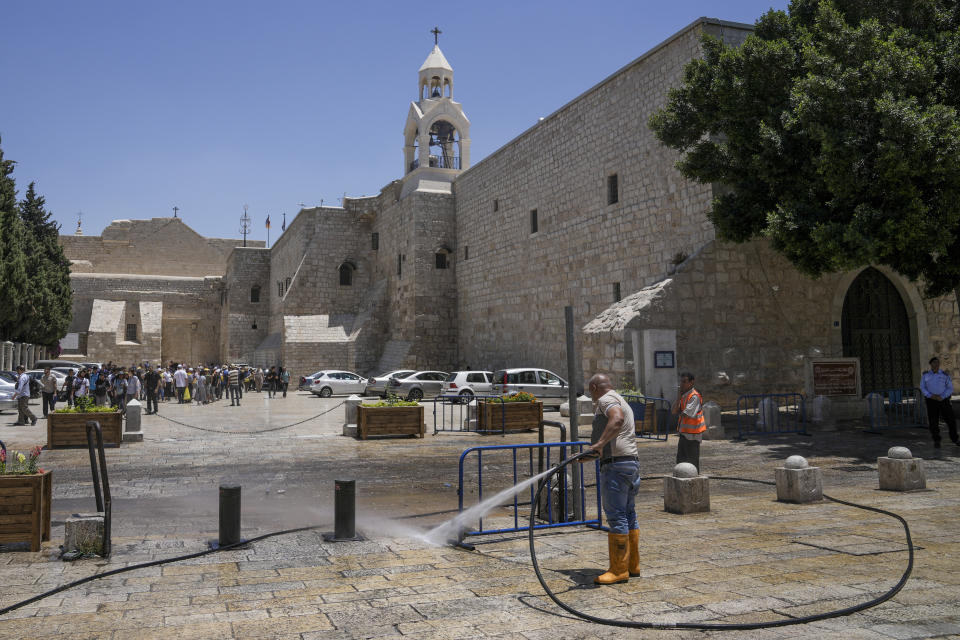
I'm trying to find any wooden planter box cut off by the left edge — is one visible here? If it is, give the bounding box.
[0,471,53,551]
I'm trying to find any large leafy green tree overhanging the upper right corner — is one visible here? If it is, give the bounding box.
[650,0,960,301]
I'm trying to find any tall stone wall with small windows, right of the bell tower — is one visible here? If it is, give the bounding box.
[455,23,748,373]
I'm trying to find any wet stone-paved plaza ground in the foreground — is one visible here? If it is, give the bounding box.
[0,394,960,640]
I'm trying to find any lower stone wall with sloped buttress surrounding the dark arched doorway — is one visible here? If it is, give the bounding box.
[583,241,960,408]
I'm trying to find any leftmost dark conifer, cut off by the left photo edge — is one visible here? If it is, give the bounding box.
[0,139,30,340]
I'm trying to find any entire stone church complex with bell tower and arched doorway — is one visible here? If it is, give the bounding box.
[62,18,960,404]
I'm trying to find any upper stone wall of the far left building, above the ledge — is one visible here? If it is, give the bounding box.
[60,218,264,277]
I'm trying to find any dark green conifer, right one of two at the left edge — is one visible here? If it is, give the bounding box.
[20,182,72,346]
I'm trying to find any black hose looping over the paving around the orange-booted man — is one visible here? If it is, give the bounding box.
[528,450,913,631]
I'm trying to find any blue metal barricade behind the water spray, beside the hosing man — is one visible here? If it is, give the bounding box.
[457,442,604,536]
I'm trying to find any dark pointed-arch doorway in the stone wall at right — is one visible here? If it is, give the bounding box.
[843,267,913,393]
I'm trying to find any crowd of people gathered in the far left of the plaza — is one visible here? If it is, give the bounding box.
[30,362,290,416]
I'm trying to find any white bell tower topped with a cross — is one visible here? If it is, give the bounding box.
[402,27,470,195]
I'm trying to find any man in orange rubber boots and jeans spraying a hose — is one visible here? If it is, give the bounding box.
[580,373,640,584]
